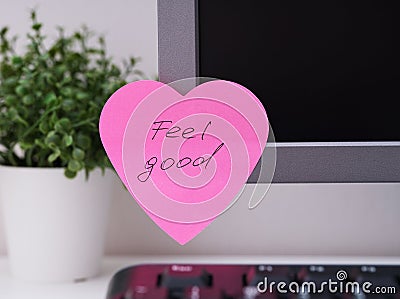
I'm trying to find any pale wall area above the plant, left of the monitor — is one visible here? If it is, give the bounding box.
[0,0,157,78]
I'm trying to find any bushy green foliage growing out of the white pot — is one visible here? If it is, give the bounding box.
[0,10,141,178]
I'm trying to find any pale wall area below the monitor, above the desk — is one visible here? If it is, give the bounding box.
[107,183,400,257]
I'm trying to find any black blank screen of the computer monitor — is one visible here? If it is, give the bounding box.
[198,0,400,142]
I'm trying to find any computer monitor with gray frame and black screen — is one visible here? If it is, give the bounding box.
[158,0,400,183]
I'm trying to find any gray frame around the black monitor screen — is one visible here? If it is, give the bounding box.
[158,0,400,183]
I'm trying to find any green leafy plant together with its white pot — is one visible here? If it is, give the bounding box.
[0,11,140,281]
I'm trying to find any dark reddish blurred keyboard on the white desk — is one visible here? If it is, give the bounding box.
[107,264,400,299]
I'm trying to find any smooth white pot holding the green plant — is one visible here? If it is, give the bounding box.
[0,166,114,282]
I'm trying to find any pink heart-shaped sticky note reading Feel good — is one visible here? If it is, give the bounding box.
[100,80,269,244]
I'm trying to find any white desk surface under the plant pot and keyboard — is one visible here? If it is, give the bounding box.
[0,256,400,299]
